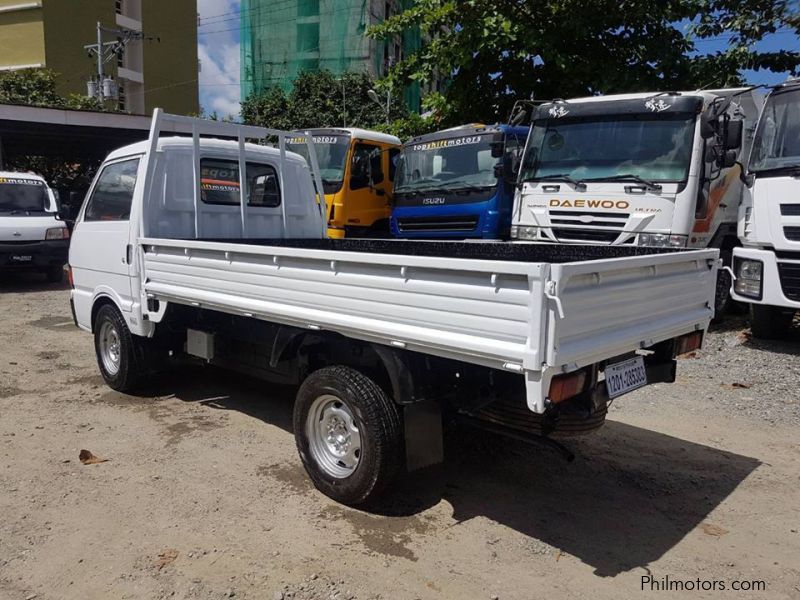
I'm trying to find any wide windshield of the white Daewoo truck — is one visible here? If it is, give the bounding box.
[520,113,695,182]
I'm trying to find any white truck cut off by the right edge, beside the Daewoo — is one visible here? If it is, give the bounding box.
[731,80,800,338]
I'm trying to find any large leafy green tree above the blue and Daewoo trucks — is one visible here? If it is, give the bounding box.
[367,0,800,122]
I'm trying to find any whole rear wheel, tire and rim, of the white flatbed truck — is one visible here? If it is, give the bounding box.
[294,366,403,506]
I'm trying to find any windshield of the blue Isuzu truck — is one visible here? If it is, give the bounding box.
[394,134,497,193]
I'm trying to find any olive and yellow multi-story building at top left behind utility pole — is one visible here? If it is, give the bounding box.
[0,0,199,114]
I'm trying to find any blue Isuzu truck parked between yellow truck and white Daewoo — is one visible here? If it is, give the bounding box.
[390,123,528,239]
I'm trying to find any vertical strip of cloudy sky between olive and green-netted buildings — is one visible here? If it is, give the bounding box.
[197,0,240,117]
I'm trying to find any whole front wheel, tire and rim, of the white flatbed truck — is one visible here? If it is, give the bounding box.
[94,304,148,392]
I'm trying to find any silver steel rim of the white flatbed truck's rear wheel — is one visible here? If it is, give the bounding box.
[306,394,361,479]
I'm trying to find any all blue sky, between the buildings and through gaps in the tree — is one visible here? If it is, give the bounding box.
[197,0,800,117]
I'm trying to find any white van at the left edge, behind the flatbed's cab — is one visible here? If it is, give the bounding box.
[0,171,69,282]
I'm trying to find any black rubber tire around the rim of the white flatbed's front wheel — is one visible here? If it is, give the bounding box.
[93,304,149,392]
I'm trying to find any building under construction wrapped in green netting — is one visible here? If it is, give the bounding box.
[241,0,420,110]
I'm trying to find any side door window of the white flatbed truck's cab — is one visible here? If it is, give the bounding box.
[83,158,139,221]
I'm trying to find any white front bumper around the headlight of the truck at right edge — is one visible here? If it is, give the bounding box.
[731,248,800,309]
